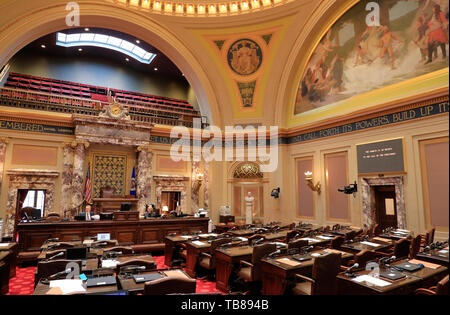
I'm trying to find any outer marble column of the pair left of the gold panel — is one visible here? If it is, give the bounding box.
[61,143,74,217]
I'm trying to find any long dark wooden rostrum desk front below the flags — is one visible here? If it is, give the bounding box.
[17,217,209,251]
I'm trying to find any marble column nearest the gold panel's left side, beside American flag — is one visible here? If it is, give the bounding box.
[72,142,89,208]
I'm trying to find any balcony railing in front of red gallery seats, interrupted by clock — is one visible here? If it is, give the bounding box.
[0,88,206,127]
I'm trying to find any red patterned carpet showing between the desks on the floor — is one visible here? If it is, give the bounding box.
[8,256,224,295]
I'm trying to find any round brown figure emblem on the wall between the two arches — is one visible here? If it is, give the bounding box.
[227,39,262,75]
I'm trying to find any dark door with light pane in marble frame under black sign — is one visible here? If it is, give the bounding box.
[373,185,398,229]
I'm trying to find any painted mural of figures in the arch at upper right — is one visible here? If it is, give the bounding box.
[294,0,449,114]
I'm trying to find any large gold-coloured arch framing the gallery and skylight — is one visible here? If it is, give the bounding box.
[0,1,223,126]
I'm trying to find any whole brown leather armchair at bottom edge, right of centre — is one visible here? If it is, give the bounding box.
[292,253,341,295]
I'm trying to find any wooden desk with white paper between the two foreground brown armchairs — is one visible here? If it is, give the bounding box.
[261,249,353,295]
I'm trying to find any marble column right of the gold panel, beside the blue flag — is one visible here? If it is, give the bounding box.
[136,146,153,214]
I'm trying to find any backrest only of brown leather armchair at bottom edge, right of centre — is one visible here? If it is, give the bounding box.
[311,253,341,295]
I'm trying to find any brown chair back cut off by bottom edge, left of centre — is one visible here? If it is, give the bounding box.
[144,277,197,295]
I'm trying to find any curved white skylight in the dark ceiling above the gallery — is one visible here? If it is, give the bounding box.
[56,32,156,64]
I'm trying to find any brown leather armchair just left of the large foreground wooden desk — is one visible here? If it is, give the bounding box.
[238,243,277,282]
